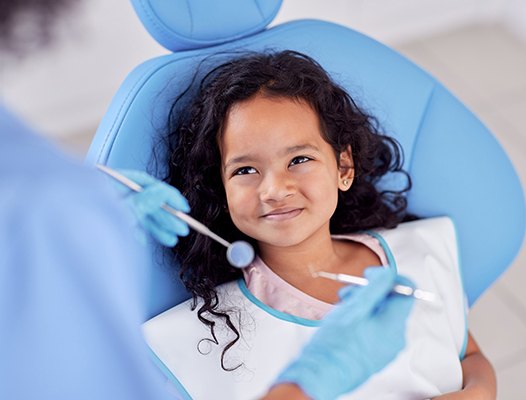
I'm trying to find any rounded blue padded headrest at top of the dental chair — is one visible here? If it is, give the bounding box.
[132,0,282,52]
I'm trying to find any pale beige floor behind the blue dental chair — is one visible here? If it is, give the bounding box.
[56,25,526,400]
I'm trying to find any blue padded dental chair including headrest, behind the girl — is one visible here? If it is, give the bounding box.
[87,0,525,317]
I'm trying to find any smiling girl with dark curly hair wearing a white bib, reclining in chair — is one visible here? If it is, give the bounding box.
[145,51,495,399]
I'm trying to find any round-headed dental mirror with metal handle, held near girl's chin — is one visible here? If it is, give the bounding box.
[97,164,255,268]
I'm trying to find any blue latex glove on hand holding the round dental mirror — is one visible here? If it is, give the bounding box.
[117,170,190,247]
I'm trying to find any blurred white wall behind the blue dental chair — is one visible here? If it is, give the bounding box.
[0,0,526,140]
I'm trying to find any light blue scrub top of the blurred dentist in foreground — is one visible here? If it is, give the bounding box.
[0,105,177,400]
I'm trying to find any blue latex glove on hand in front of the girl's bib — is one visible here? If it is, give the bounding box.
[276,267,414,400]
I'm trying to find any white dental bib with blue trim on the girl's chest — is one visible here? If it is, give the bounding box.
[143,217,467,400]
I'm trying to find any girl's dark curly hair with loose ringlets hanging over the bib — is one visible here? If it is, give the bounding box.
[167,51,411,369]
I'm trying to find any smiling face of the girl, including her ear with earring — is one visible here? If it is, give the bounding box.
[220,95,353,250]
